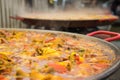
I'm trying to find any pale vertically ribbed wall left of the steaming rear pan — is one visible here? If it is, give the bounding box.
[0,0,25,28]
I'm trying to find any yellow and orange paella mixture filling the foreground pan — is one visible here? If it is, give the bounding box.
[0,30,115,80]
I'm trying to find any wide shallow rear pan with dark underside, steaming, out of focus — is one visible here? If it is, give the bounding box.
[10,14,118,28]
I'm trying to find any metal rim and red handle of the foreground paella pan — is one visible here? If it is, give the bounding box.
[1,29,120,80]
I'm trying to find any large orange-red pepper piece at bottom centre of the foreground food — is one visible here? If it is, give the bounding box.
[48,63,68,73]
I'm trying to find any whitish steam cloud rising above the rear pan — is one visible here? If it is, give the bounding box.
[7,0,109,16]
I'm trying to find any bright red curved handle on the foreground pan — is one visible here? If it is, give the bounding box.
[87,30,120,42]
